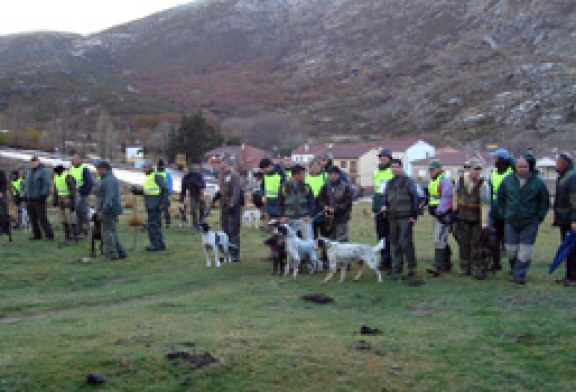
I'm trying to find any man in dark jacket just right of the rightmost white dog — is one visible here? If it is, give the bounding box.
[383,159,418,278]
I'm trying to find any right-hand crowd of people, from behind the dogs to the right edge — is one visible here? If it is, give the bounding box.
[260,148,576,284]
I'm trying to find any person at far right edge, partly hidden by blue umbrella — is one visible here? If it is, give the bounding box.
[554,153,576,284]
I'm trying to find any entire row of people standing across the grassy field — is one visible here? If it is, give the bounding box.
[0,148,576,284]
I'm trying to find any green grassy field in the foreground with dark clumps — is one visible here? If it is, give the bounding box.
[0,205,576,391]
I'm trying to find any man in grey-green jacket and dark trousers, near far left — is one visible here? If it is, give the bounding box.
[25,156,54,241]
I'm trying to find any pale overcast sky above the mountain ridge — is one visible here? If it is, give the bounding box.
[0,0,197,35]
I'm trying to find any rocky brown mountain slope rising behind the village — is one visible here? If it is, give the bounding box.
[0,0,576,150]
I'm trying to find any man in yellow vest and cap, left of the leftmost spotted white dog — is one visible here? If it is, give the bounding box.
[132,162,168,252]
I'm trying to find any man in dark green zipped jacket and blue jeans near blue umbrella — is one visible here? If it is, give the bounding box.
[498,154,550,284]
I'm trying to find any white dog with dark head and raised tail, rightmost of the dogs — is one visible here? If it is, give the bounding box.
[318,239,386,283]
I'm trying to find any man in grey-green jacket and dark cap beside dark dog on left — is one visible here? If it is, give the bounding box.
[94,160,126,261]
